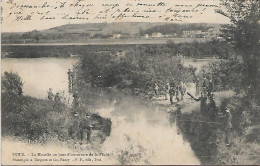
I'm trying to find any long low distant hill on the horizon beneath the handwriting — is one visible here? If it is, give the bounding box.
[1,22,220,44]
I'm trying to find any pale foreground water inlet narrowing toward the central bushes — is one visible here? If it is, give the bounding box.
[96,98,200,164]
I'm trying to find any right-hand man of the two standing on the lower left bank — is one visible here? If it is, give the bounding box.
[79,113,93,143]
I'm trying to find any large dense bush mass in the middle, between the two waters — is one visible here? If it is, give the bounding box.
[75,46,195,102]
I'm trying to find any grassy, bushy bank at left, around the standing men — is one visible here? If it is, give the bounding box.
[1,92,111,146]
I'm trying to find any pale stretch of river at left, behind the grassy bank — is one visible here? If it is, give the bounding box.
[1,58,76,98]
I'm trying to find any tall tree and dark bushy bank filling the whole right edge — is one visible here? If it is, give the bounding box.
[180,0,260,165]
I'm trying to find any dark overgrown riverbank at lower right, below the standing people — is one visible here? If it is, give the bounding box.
[151,91,260,165]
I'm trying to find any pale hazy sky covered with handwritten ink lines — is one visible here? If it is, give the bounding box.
[1,0,228,32]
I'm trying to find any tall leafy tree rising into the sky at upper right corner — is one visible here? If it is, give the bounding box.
[216,0,260,99]
